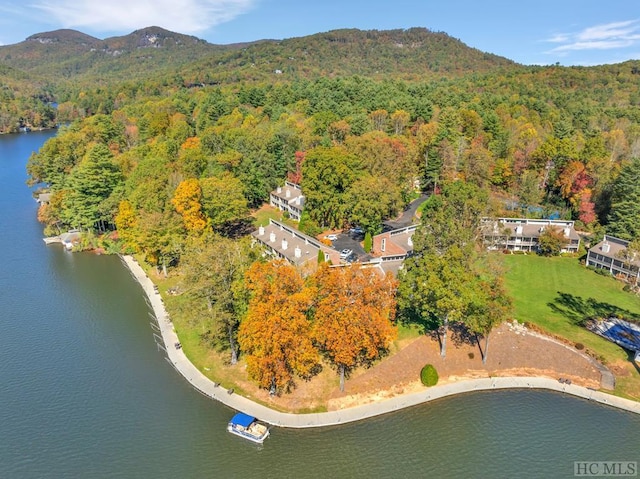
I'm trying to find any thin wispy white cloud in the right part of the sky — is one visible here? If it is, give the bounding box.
[546,20,640,55]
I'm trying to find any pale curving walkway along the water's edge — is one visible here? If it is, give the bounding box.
[120,255,640,428]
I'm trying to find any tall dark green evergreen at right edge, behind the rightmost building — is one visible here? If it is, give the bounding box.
[606,158,640,241]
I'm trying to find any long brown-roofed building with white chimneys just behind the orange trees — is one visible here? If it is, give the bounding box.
[251,220,340,269]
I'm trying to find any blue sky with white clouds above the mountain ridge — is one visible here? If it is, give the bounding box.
[0,0,640,65]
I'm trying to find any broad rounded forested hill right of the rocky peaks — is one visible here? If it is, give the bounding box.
[184,28,517,81]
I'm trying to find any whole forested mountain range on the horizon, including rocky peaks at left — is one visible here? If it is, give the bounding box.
[0,27,517,82]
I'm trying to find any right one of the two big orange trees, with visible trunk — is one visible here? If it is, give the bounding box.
[313,266,397,391]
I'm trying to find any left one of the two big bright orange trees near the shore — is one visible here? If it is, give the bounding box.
[238,261,319,392]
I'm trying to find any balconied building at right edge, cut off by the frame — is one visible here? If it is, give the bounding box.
[587,235,640,282]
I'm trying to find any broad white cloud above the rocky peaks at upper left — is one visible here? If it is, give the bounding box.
[32,0,256,33]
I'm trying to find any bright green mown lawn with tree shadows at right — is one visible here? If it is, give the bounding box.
[505,255,640,370]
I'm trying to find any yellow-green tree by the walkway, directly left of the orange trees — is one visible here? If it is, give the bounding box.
[180,234,254,364]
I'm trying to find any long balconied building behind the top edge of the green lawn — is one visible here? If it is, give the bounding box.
[481,218,580,253]
